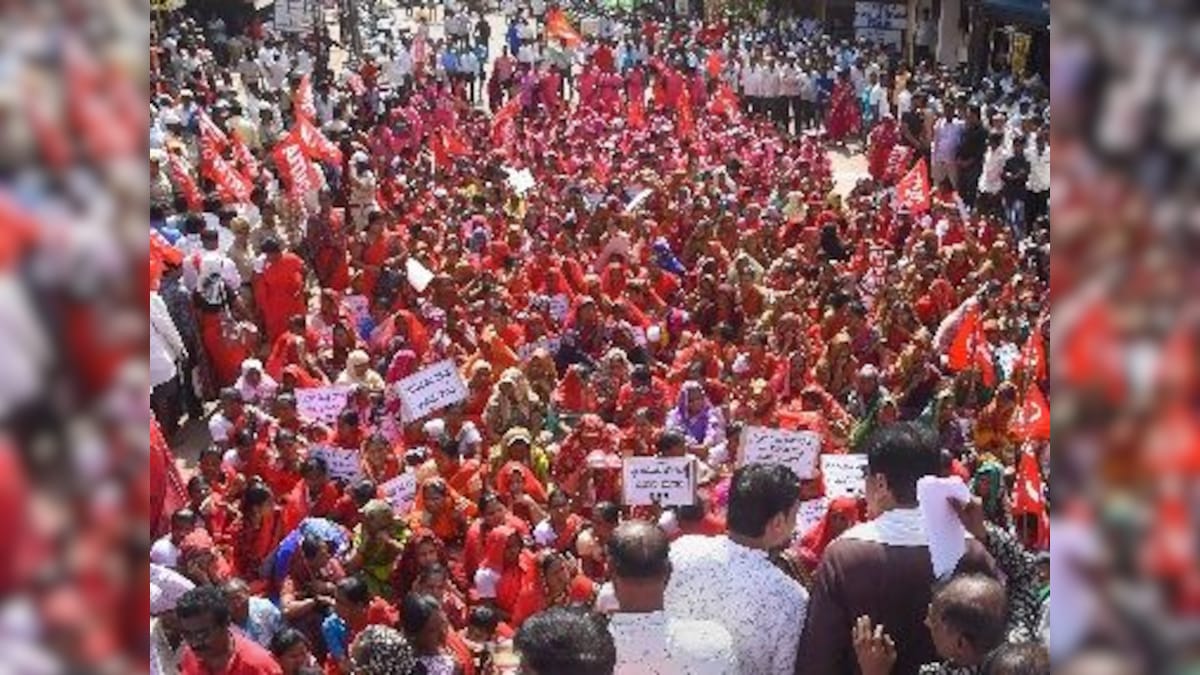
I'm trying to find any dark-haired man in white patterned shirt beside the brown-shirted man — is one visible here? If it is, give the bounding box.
[666,464,809,674]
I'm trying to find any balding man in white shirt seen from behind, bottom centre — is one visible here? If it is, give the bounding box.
[608,520,739,675]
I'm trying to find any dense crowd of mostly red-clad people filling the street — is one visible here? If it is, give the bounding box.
[149,4,1049,675]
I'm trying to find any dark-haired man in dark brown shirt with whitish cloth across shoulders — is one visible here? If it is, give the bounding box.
[796,423,996,675]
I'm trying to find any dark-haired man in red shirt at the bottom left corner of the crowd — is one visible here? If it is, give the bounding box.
[175,586,283,675]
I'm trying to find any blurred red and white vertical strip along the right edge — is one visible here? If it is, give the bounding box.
[1050,1,1200,673]
